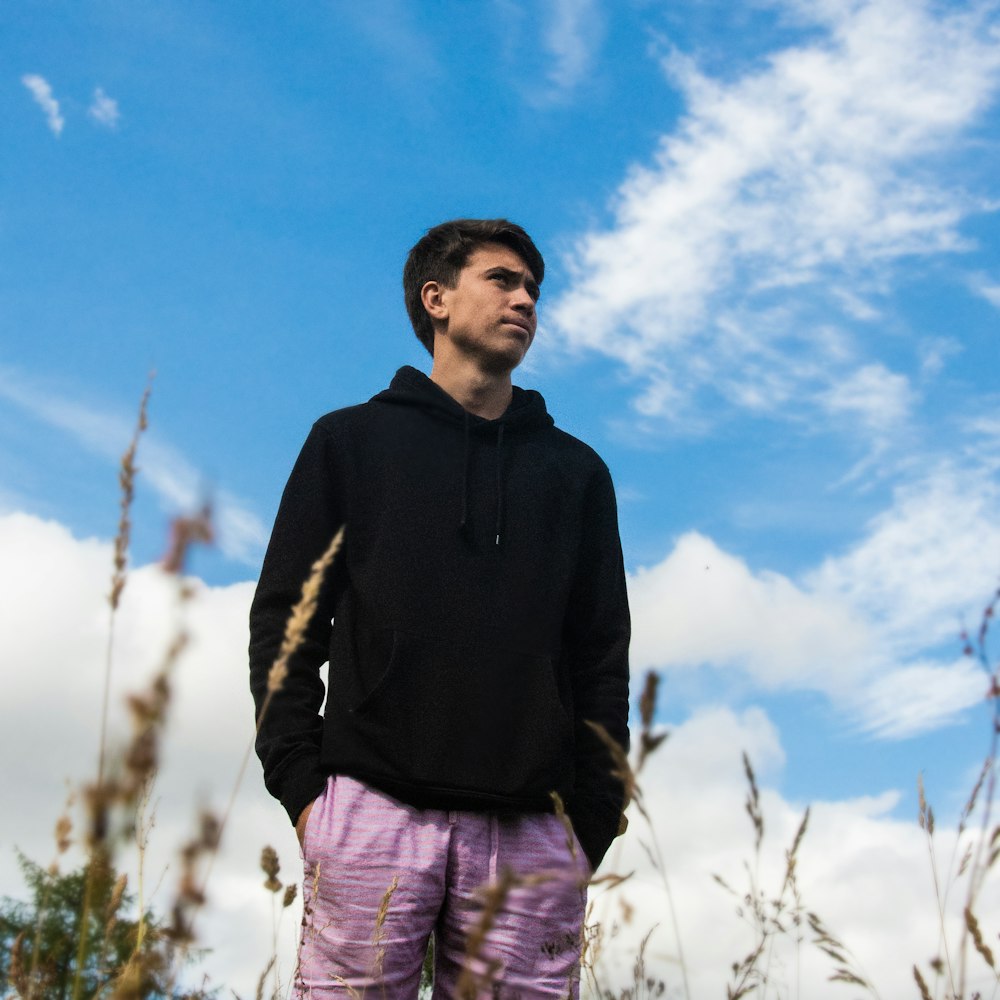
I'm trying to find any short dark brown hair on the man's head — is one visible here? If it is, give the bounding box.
[403,219,545,357]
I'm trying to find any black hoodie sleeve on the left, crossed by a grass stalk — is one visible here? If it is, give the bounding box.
[250,424,343,823]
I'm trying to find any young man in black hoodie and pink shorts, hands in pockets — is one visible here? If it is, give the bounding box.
[250,219,629,1000]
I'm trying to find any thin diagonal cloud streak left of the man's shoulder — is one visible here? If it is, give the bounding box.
[0,368,266,566]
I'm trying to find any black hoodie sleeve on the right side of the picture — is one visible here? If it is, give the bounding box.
[564,463,631,869]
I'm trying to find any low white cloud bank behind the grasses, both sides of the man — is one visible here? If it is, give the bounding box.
[0,514,1000,1000]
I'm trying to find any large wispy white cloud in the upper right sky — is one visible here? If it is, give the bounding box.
[547,0,1000,420]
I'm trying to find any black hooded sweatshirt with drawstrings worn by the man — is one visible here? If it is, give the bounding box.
[250,367,629,867]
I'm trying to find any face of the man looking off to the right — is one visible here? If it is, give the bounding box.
[432,243,538,373]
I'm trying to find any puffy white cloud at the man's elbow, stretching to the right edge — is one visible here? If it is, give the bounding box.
[629,465,1000,739]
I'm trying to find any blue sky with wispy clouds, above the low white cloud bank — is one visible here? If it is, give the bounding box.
[0,0,1000,992]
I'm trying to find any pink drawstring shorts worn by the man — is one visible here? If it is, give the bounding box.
[295,776,590,1000]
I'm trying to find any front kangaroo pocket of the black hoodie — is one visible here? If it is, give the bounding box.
[327,631,573,800]
